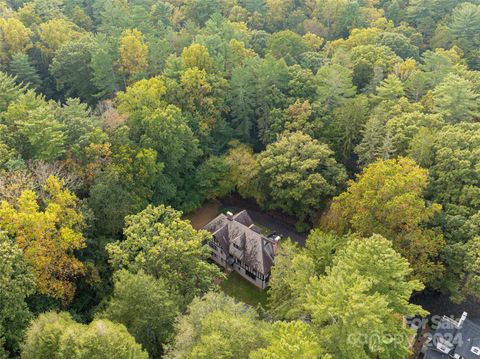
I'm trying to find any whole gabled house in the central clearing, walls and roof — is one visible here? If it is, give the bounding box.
[204,210,279,289]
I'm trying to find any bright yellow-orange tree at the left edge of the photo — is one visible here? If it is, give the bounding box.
[0,176,85,304]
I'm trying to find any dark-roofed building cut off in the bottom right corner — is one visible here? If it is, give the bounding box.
[424,312,480,359]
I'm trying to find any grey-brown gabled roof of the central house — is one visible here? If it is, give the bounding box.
[204,210,274,275]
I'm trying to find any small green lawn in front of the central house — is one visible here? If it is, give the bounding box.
[220,272,267,308]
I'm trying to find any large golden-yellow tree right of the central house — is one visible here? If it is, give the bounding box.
[322,158,444,285]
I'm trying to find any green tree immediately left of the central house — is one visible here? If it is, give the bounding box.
[107,205,221,308]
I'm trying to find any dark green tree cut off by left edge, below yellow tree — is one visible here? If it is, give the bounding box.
[0,233,35,357]
